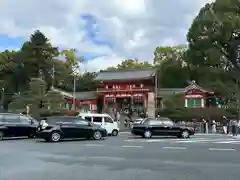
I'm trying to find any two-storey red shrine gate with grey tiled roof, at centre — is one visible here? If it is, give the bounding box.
[96,69,155,116]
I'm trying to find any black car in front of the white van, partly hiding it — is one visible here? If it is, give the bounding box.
[36,116,107,142]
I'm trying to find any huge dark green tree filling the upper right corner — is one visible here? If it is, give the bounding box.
[186,0,240,118]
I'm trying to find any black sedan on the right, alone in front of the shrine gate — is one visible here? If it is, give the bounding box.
[131,117,194,138]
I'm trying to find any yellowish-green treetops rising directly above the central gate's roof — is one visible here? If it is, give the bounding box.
[107,59,153,70]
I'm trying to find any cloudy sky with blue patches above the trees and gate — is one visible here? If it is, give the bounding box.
[0,0,212,71]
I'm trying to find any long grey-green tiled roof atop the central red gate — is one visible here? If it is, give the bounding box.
[95,68,155,81]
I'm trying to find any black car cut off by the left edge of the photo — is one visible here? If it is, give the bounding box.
[0,113,39,140]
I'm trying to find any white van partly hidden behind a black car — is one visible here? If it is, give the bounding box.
[78,113,119,136]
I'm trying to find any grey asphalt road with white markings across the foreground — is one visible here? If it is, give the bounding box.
[0,134,240,180]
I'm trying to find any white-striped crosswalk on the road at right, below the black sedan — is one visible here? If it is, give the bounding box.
[124,138,240,144]
